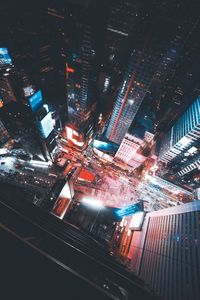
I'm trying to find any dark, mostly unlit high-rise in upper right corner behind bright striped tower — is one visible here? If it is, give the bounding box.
[154,1,200,132]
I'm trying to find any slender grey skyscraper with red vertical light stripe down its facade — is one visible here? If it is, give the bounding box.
[106,50,157,144]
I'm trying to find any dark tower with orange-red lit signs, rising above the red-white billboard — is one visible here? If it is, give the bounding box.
[65,0,103,126]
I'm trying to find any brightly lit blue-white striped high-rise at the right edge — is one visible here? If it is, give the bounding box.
[159,97,200,188]
